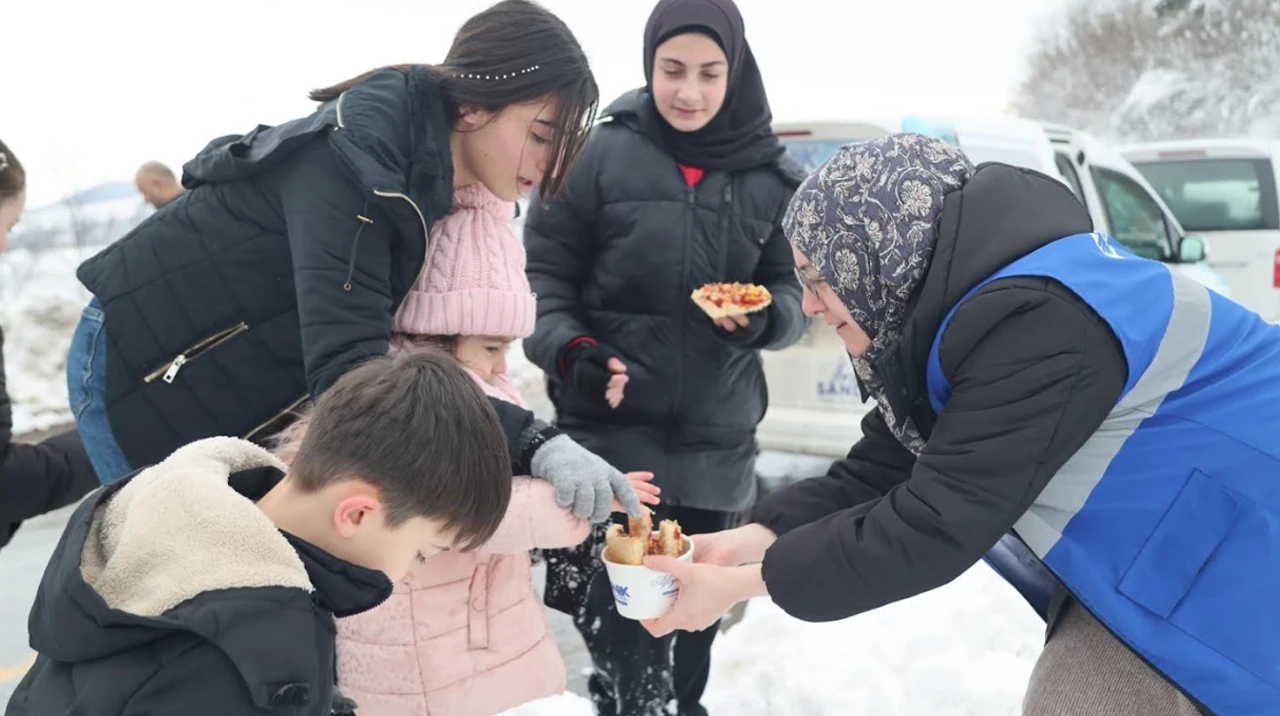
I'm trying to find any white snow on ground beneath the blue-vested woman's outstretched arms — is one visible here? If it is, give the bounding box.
[504,564,1044,716]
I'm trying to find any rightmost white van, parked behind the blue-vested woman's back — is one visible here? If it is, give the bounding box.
[1121,140,1280,323]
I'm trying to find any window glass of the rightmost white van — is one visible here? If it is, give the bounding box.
[1134,159,1280,232]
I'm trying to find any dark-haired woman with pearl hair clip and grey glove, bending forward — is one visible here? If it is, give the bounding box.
[67,0,639,520]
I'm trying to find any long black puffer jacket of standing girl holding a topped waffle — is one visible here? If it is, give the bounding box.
[525,91,805,511]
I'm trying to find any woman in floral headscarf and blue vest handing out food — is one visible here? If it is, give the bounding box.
[646,134,1280,716]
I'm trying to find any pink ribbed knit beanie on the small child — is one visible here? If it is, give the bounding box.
[393,184,535,338]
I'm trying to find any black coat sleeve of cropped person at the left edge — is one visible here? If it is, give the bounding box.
[0,330,99,547]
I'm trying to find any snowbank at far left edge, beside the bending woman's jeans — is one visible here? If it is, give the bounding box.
[0,247,100,434]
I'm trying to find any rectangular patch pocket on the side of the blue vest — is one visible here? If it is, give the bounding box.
[1119,470,1240,619]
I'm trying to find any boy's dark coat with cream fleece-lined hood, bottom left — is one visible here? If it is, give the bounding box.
[5,446,392,716]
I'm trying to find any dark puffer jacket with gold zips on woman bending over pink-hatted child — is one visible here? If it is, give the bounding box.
[78,68,532,466]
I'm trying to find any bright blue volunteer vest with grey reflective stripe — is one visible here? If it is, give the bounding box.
[927,233,1280,716]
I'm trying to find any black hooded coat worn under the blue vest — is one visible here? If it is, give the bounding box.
[751,164,1128,621]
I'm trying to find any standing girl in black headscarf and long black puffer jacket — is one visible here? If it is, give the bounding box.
[525,0,805,716]
